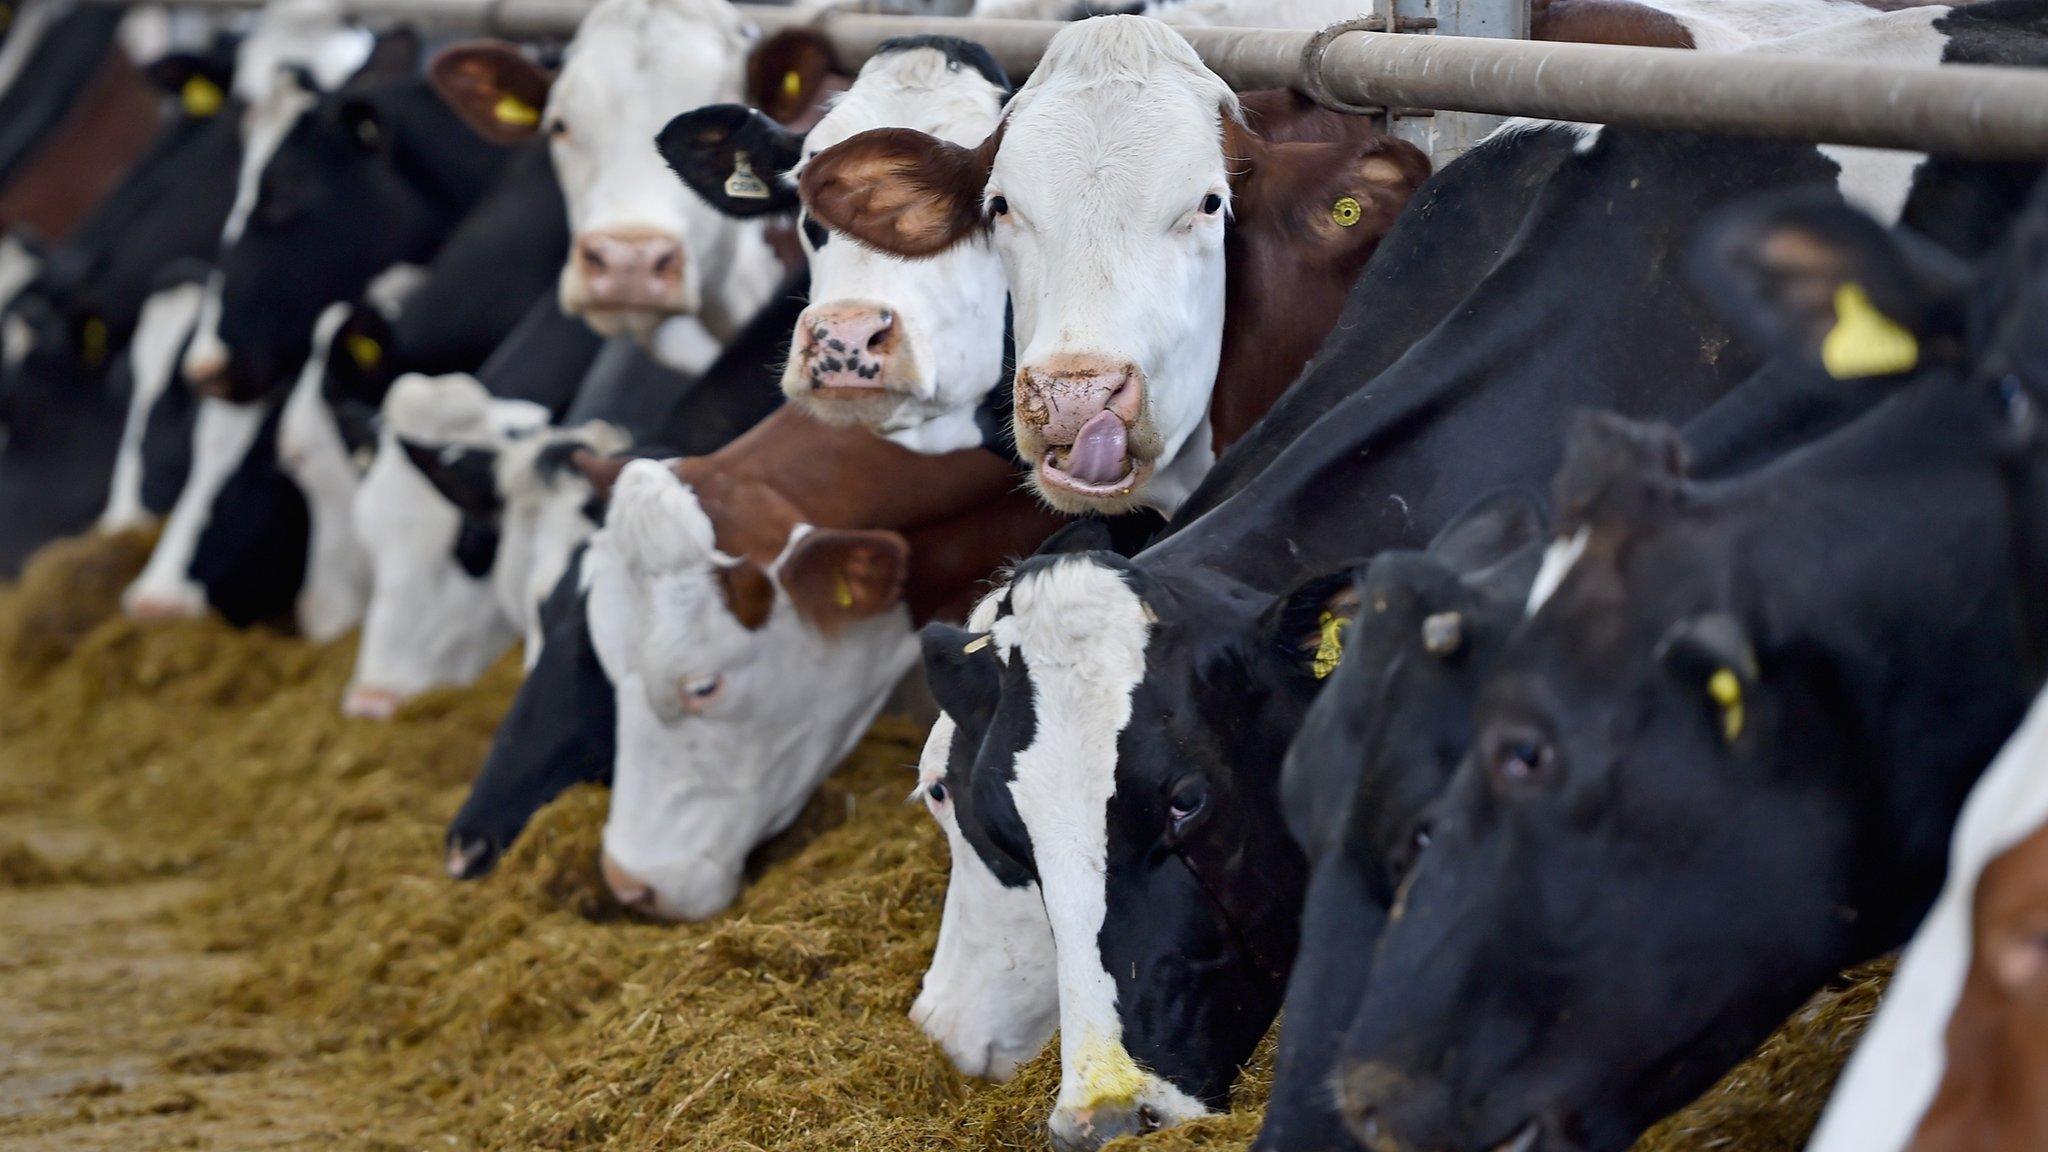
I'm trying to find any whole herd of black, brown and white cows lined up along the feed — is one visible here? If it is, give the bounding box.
[0,0,2048,1152]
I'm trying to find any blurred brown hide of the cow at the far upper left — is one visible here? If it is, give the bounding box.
[0,49,162,244]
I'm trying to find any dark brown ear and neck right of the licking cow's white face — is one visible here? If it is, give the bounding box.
[1208,90,1430,451]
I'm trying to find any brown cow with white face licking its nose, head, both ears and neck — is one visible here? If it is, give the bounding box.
[799,16,1427,512]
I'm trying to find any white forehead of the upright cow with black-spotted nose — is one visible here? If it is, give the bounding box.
[805,47,1004,156]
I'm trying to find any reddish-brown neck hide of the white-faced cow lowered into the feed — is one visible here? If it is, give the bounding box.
[672,408,1063,623]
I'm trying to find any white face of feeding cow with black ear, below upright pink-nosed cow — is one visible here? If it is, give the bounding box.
[342,375,547,717]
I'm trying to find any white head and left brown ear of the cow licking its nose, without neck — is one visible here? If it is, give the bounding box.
[801,16,1407,510]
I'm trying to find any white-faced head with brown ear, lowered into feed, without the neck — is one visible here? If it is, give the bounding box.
[584,461,915,920]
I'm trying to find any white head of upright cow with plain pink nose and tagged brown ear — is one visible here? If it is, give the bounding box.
[432,0,760,340]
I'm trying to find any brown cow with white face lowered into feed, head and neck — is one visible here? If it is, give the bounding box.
[582,408,1057,920]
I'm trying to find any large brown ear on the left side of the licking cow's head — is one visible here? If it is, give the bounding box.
[797,125,1004,256]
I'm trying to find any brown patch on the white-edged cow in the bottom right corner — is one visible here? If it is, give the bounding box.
[1909,815,2048,1152]
